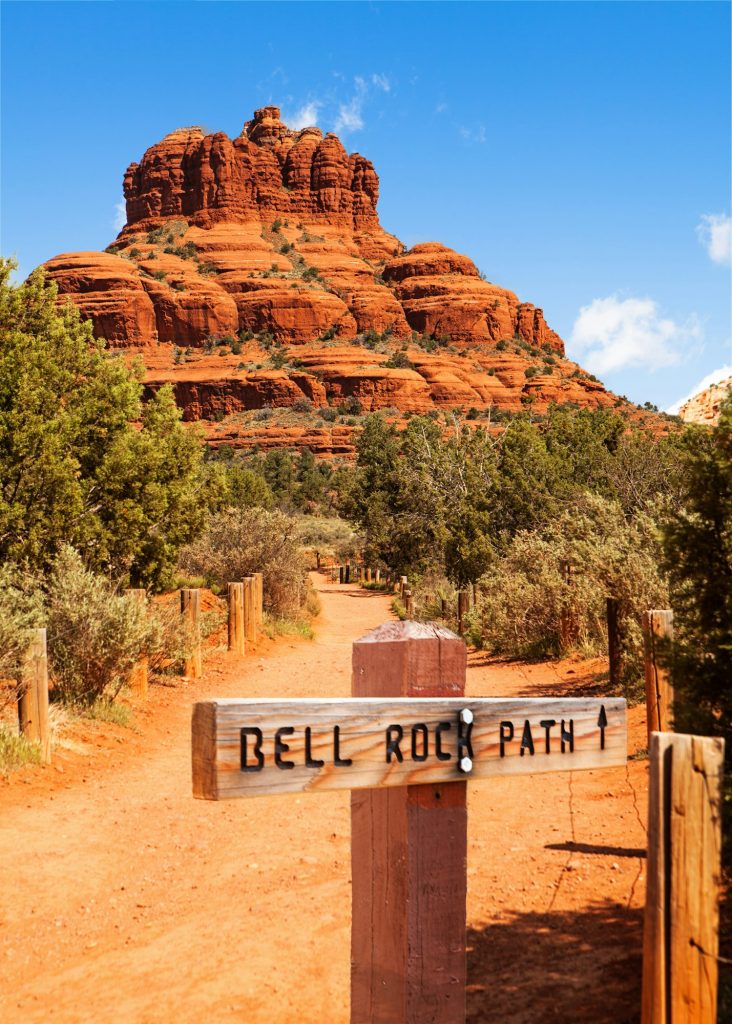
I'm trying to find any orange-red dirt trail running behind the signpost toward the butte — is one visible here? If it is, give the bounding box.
[0,577,646,1024]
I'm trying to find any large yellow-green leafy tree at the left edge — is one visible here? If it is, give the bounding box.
[0,261,205,587]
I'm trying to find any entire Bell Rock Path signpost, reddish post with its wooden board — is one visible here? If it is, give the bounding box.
[192,621,627,1024]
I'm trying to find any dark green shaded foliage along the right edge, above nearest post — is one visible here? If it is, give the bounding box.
[663,398,732,749]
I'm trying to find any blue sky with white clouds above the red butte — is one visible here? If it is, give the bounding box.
[0,0,732,408]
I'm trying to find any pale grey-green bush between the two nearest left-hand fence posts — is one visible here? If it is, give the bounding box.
[45,547,156,705]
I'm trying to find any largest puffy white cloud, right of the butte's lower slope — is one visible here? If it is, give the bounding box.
[570,295,702,374]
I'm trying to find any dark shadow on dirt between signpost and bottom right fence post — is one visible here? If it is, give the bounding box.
[468,902,643,1024]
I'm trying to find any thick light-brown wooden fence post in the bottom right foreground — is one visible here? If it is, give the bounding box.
[641,732,724,1024]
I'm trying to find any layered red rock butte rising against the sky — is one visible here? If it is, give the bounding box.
[45,106,617,454]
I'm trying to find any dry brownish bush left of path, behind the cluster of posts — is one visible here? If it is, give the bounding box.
[180,508,307,614]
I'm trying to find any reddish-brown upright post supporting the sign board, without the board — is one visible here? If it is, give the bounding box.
[351,622,468,1024]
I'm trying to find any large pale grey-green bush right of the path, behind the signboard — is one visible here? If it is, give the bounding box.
[480,493,669,678]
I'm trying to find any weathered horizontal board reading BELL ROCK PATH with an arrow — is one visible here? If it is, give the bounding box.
[192,697,627,800]
